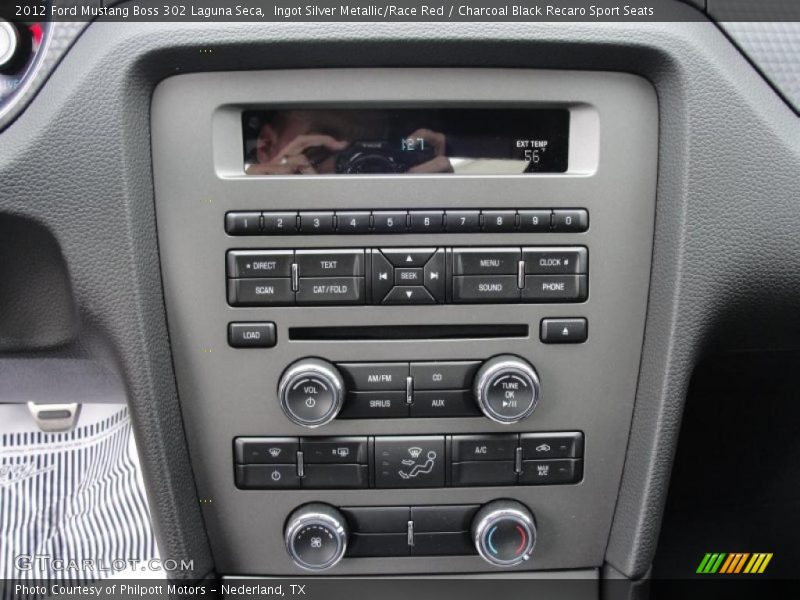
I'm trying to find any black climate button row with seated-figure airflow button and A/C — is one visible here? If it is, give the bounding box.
[234,431,584,490]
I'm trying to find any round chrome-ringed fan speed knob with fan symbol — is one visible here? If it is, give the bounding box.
[284,502,349,571]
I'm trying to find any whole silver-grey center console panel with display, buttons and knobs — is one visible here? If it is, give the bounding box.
[152,69,658,575]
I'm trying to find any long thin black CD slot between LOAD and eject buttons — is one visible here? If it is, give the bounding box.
[289,324,528,342]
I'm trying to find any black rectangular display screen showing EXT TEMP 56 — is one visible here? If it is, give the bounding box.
[242,108,569,175]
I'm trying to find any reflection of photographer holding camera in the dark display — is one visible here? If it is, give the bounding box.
[245,110,453,175]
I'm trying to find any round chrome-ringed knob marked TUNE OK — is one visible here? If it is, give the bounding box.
[475,354,539,425]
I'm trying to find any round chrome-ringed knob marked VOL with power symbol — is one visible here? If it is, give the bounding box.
[278,358,344,427]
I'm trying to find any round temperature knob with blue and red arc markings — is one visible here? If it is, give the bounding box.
[472,500,536,567]
